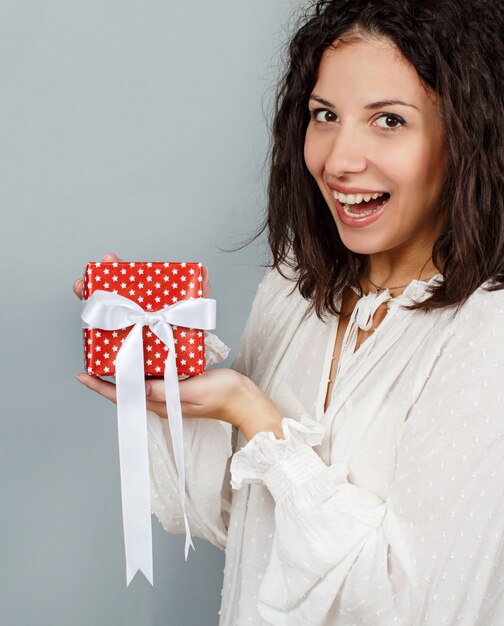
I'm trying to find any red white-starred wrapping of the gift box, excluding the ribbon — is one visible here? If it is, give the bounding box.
[83,262,205,376]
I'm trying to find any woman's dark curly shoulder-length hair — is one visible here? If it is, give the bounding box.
[262,0,504,317]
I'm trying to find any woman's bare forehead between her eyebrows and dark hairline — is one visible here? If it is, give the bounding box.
[314,38,435,105]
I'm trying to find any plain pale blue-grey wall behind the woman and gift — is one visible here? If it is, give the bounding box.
[0,0,306,626]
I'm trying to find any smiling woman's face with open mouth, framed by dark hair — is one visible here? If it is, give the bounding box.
[304,39,446,262]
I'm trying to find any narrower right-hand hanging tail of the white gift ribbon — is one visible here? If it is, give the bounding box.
[161,324,195,561]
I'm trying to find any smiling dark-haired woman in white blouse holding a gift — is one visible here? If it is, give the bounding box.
[75,0,504,626]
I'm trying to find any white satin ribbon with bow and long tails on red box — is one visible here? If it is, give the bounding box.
[81,290,216,586]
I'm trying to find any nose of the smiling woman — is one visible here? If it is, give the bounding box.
[325,125,367,178]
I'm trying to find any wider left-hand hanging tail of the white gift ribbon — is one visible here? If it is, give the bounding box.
[116,324,154,586]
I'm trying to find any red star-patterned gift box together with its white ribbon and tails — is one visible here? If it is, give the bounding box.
[81,262,216,585]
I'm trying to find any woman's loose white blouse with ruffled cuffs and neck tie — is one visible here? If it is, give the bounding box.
[148,271,504,626]
